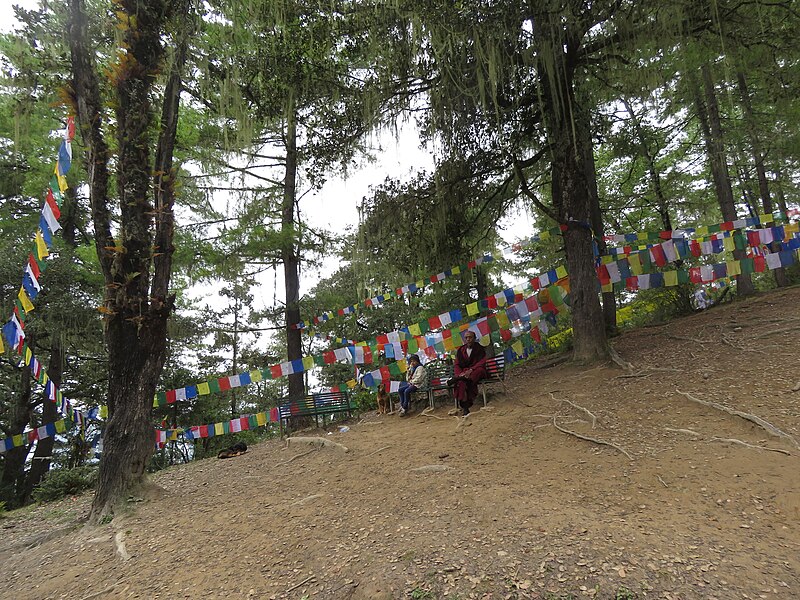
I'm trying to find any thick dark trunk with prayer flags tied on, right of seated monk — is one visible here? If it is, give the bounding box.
[529,9,608,362]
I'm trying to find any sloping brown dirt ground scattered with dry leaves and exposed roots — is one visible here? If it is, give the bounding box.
[0,288,800,600]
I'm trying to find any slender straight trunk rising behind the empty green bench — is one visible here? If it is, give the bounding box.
[281,93,305,398]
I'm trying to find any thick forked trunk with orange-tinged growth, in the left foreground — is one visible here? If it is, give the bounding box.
[68,0,191,522]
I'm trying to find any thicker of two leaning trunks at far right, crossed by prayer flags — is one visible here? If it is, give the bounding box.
[694,64,755,296]
